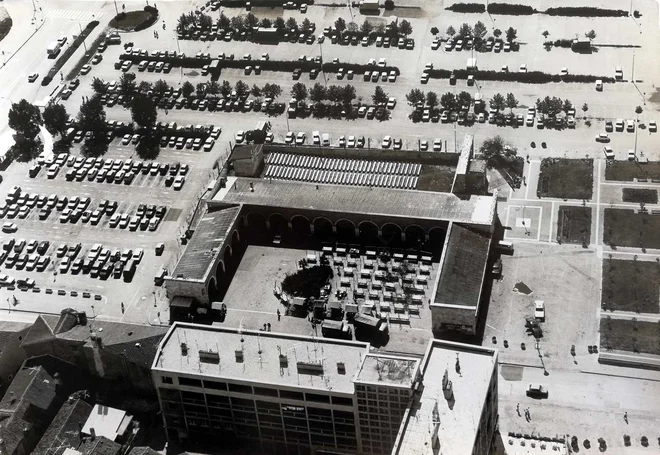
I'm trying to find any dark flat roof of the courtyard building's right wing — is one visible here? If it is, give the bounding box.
[433,223,491,307]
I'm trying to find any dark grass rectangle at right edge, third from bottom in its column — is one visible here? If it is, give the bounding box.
[603,209,660,250]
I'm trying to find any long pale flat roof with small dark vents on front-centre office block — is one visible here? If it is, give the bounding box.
[152,322,369,394]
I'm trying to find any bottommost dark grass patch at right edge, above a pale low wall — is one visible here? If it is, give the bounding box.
[600,317,660,355]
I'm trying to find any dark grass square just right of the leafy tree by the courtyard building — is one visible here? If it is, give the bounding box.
[536,158,594,200]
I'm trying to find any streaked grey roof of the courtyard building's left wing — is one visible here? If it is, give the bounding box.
[170,207,240,281]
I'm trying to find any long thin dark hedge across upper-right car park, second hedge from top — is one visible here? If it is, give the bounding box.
[428,70,614,84]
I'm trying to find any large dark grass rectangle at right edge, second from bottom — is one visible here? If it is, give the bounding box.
[601,259,660,314]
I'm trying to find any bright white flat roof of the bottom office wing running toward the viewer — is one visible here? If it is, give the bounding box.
[392,340,497,455]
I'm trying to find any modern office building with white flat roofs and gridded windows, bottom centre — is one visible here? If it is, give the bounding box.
[152,322,497,455]
